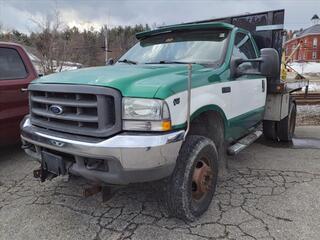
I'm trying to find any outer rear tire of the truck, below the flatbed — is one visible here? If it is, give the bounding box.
[278,100,297,142]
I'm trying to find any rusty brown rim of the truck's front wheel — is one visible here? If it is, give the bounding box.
[191,158,213,201]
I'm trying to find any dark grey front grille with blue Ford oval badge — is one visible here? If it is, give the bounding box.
[29,84,121,137]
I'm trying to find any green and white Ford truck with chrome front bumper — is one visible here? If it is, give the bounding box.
[21,10,295,220]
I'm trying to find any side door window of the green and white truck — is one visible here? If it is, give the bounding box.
[233,32,258,70]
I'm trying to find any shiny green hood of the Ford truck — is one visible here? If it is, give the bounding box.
[33,64,208,98]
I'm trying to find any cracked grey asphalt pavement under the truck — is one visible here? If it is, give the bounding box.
[0,126,320,240]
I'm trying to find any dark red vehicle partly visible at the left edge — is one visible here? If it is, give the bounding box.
[0,42,38,146]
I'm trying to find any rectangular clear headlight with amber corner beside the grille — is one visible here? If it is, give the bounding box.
[122,98,171,131]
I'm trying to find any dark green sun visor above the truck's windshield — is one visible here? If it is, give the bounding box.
[136,22,235,40]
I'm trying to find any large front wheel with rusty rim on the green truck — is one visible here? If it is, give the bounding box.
[166,135,218,221]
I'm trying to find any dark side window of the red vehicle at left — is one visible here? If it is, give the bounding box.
[0,48,28,80]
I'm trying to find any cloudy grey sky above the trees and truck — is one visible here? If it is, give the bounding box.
[0,0,320,33]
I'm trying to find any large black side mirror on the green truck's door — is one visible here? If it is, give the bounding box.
[230,48,280,80]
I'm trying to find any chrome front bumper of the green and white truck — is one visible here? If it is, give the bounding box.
[21,117,185,184]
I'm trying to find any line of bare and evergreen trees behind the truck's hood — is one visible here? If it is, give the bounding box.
[0,21,150,74]
